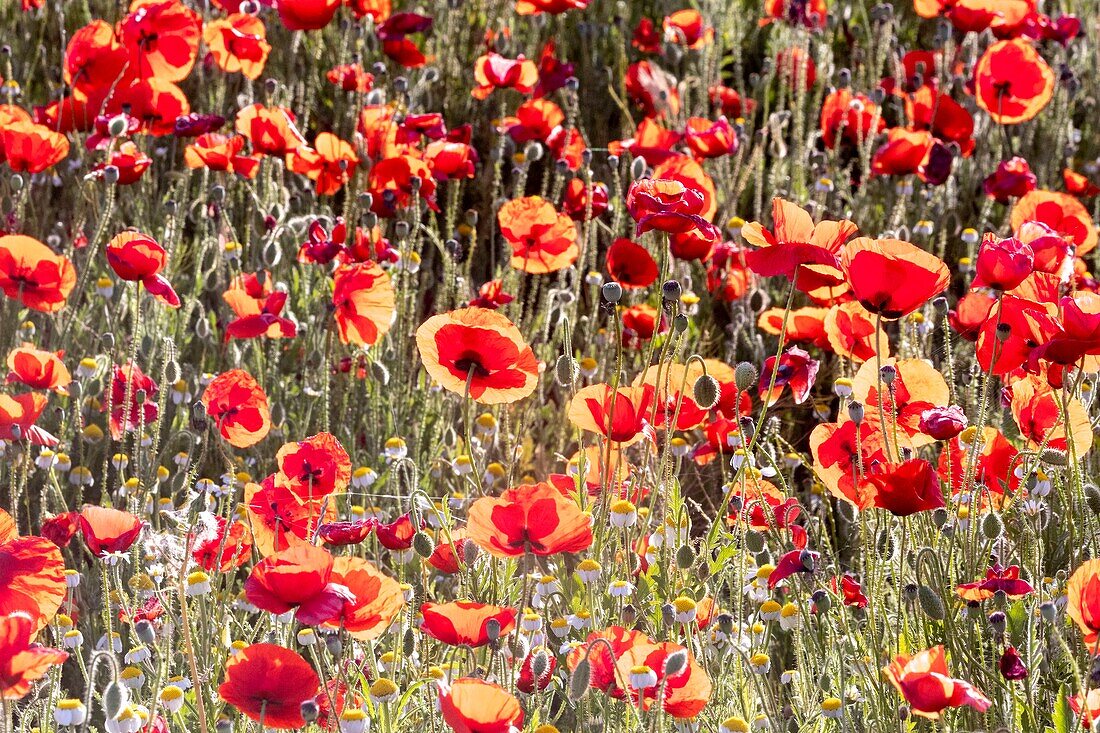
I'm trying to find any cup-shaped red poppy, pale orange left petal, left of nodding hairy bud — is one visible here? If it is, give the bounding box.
[569,384,656,444]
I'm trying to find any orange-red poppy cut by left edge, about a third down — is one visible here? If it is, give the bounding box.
[0,234,76,313]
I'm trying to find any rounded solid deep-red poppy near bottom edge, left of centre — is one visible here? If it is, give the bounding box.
[218,644,321,730]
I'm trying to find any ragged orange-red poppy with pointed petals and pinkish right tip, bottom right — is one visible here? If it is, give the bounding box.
[882,645,993,720]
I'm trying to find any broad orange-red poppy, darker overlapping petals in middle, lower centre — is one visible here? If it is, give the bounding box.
[466,483,592,558]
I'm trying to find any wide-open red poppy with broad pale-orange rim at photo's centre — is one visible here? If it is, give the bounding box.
[416,305,539,405]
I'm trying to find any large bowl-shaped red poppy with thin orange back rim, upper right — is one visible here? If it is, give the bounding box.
[840,237,950,318]
